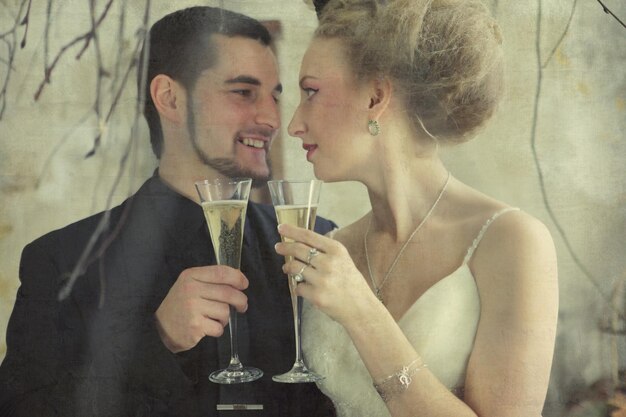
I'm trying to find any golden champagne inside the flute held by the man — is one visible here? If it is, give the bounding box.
[202,200,248,268]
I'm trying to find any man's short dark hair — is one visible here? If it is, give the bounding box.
[137,6,272,158]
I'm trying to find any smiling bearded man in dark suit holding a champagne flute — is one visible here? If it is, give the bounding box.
[0,7,334,417]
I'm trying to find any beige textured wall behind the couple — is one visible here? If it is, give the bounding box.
[0,0,626,416]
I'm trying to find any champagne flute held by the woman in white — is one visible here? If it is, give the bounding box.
[267,180,324,383]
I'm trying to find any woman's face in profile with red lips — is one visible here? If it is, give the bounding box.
[289,38,371,181]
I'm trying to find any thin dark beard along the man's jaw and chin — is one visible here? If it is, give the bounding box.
[187,95,272,188]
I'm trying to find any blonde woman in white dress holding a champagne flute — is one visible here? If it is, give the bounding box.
[276,0,558,417]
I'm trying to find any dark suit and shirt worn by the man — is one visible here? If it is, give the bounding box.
[0,175,334,417]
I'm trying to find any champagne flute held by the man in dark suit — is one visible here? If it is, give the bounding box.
[195,178,263,384]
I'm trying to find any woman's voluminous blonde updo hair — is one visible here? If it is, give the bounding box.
[315,0,503,144]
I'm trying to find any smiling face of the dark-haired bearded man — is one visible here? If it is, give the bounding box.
[187,35,282,182]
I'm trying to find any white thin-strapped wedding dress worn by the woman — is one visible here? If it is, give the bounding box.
[302,208,517,417]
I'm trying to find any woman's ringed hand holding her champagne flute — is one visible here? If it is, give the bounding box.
[276,224,381,328]
